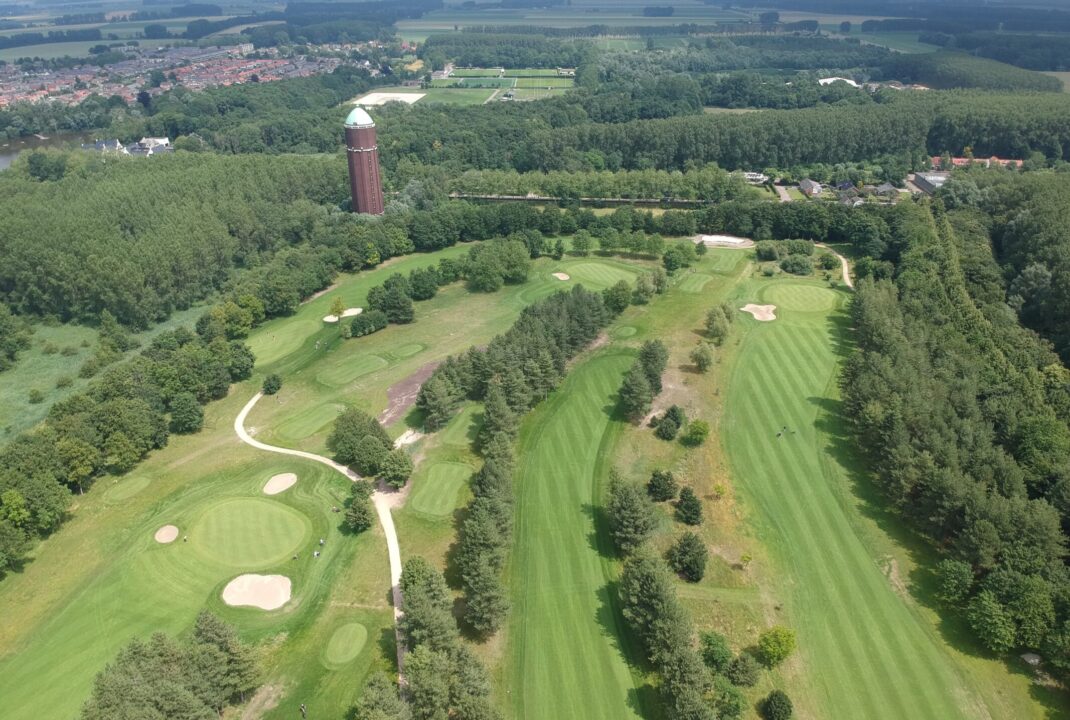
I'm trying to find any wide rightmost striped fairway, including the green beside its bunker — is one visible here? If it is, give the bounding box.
[722,280,982,720]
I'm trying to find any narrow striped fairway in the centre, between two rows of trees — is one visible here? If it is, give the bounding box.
[504,350,642,720]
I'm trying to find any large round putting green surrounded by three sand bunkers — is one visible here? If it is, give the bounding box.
[189,497,311,570]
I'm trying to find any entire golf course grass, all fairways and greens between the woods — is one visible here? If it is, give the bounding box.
[0,242,1045,720]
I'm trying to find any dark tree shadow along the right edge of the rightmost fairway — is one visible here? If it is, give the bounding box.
[808,312,1070,720]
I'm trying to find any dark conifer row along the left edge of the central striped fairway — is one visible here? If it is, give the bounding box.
[416,286,615,634]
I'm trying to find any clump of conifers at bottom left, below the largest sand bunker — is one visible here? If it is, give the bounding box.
[79,611,259,720]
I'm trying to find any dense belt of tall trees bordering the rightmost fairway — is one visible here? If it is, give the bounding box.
[841,203,1070,675]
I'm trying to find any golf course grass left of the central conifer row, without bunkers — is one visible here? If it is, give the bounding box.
[0,242,659,720]
